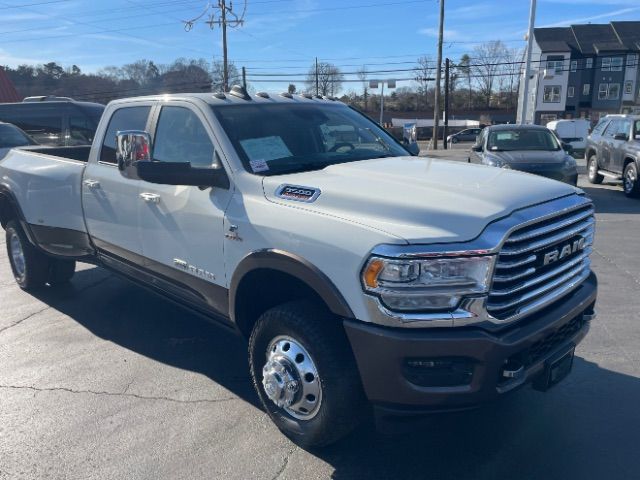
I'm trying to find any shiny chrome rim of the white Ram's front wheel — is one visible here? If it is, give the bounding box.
[262,336,322,420]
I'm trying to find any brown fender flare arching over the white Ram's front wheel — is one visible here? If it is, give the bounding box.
[229,249,355,323]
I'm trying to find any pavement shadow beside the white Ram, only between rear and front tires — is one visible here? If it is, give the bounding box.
[30,268,259,406]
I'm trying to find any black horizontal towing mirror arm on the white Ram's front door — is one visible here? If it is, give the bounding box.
[134,161,229,189]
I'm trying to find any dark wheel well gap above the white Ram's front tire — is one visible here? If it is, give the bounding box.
[234,268,328,338]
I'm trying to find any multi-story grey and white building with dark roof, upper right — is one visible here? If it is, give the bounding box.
[518,21,640,125]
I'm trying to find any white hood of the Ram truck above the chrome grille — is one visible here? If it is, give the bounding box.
[263,157,576,243]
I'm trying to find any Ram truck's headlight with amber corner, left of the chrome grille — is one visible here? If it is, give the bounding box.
[362,256,495,311]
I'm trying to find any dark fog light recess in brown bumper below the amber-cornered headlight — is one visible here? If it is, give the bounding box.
[403,357,474,387]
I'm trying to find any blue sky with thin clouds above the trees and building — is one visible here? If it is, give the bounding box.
[0,0,640,90]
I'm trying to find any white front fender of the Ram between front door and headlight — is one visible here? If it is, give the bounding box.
[224,174,406,321]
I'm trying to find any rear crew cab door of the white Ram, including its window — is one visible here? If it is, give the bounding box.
[82,102,153,261]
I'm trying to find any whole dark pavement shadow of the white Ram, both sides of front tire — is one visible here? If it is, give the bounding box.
[28,268,640,480]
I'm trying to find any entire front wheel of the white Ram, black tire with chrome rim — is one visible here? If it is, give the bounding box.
[249,301,366,448]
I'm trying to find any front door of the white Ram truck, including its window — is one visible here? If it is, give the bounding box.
[136,101,233,314]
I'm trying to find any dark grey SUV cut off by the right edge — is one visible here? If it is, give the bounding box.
[585,115,640,198]
